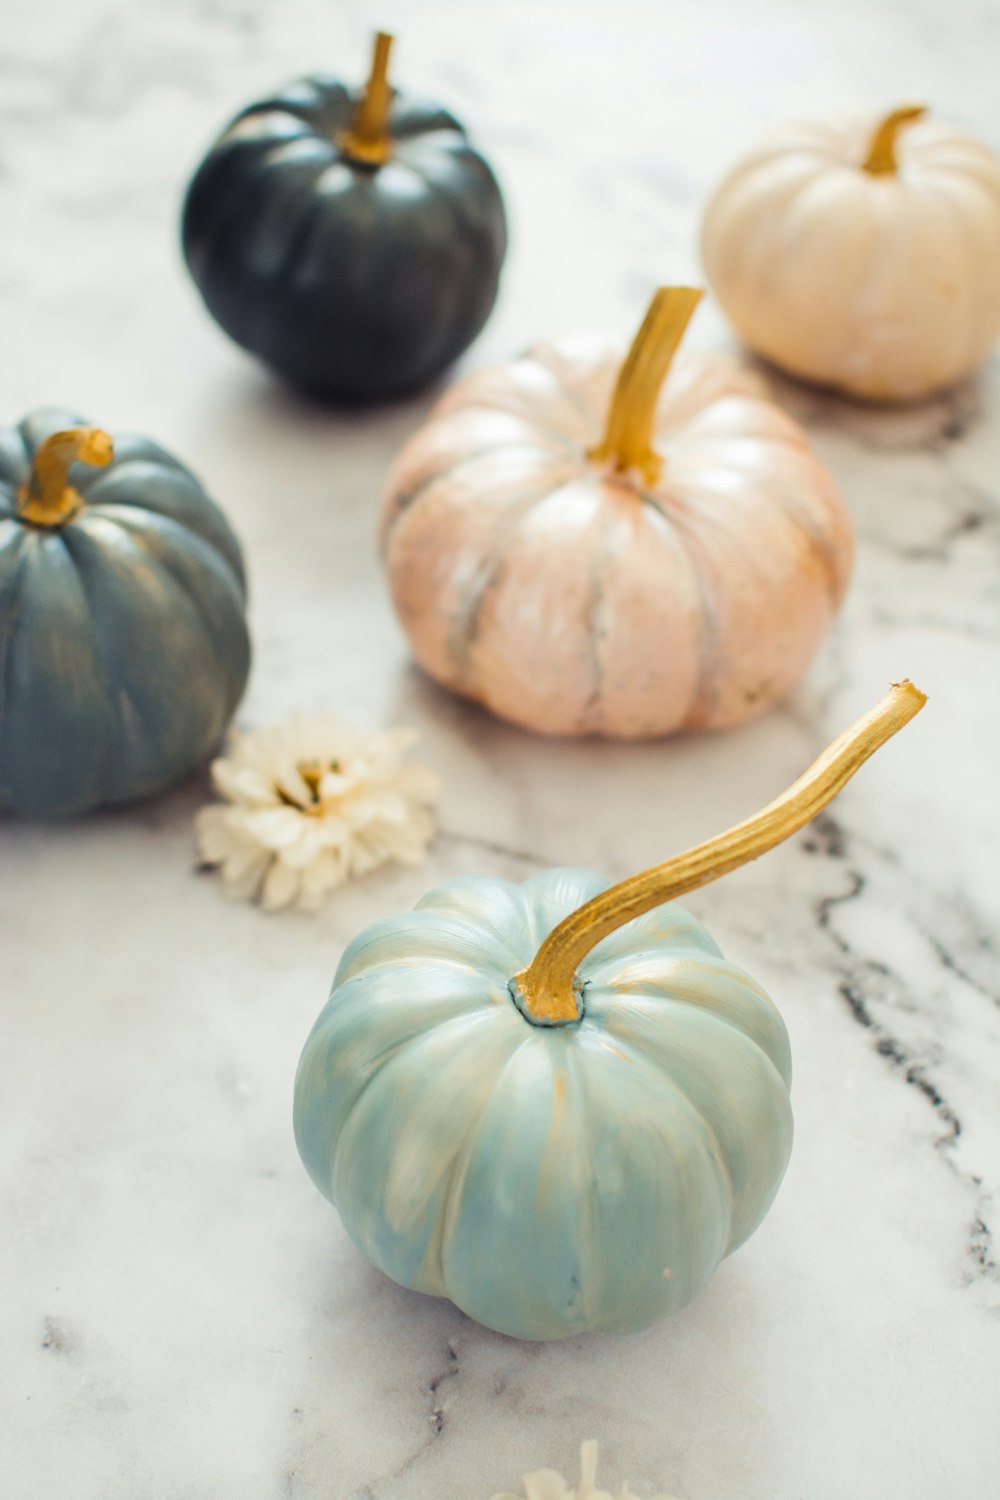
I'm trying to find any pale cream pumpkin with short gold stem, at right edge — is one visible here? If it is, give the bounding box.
[702,107,1000,401]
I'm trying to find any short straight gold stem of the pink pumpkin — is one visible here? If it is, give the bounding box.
[588,287,702,485]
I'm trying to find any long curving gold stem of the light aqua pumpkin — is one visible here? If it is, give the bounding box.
[514,680,927,1023]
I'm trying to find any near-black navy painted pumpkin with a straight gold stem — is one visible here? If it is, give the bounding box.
[183,33,507,401]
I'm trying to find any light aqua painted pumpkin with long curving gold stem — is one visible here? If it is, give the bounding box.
[294,683,924,1340]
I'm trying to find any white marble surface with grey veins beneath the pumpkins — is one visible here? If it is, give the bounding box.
[0,0,1000,1500]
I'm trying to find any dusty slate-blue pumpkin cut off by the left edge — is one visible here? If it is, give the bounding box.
[0,411,250,818]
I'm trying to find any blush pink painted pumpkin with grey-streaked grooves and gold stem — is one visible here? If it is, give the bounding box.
[382,288,853,740]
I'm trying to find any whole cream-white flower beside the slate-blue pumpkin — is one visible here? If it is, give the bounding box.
[195,714,439,911]
